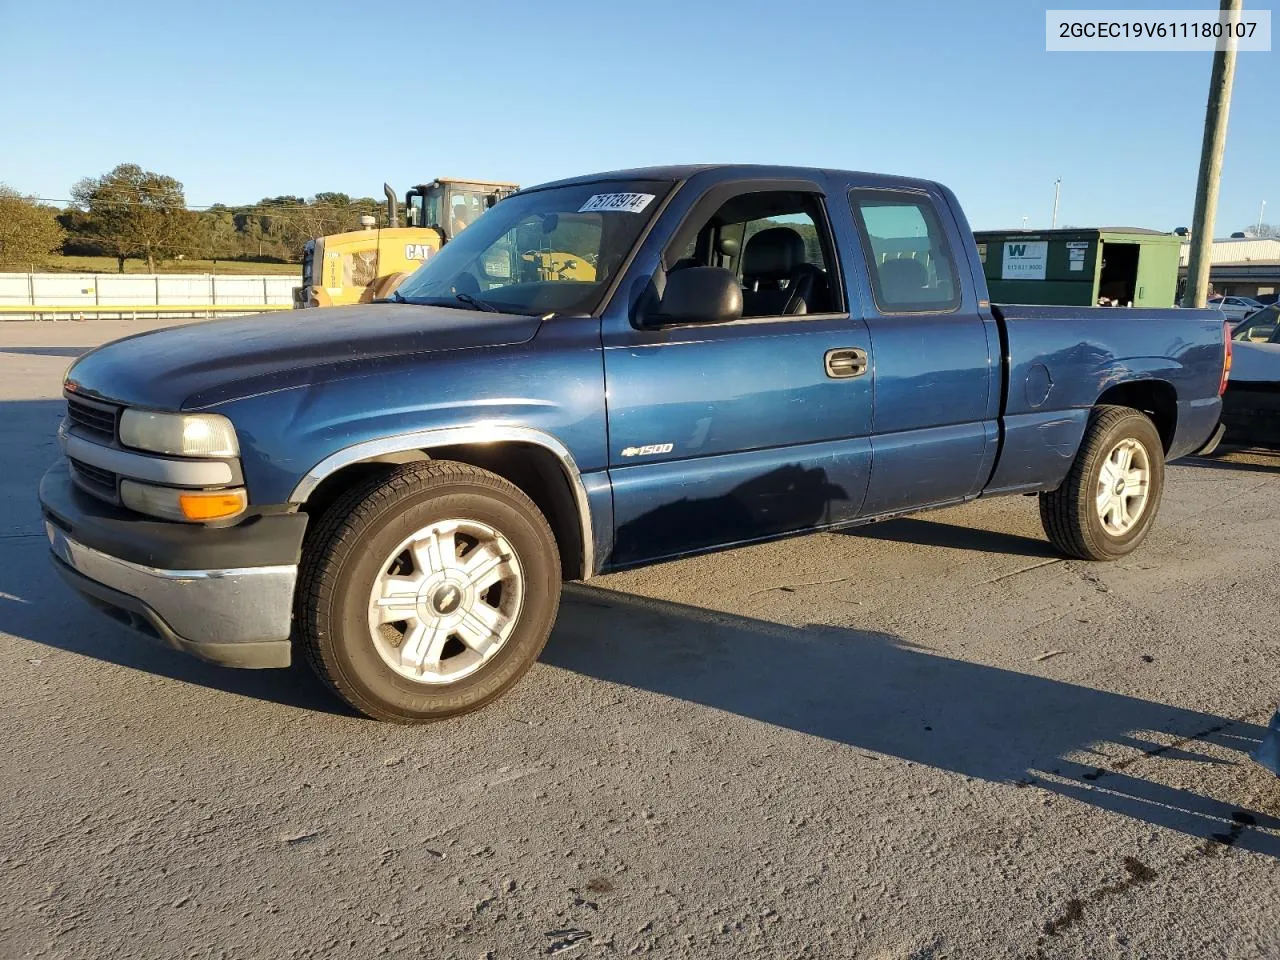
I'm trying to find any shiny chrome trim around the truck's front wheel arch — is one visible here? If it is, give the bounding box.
[289,424,595,580]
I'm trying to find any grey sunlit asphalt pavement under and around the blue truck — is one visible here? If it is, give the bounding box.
[0,321,1280,960]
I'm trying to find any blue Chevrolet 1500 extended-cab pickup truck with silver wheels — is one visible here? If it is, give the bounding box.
[40,165,1228,722]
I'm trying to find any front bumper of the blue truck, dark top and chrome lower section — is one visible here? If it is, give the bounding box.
[40,465,306,667]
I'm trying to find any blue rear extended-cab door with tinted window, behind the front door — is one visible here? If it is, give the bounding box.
[849,187,1002,516]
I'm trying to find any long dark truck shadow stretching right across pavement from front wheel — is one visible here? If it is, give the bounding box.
[543,585,1280,858]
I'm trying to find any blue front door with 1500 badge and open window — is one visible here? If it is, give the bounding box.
[604,182,872,567]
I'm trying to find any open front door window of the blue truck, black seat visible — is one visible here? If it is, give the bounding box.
[666,191,842,317]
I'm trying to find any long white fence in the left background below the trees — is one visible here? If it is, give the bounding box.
[0,274,302,320]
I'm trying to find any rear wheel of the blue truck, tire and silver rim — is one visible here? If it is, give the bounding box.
[1039,406,1165,561]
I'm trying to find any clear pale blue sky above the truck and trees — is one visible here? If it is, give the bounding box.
[0,0,1280,236]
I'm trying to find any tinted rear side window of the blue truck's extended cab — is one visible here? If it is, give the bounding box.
[849,189,960,314]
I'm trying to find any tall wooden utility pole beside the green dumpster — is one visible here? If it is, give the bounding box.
[1183,0,1243,307]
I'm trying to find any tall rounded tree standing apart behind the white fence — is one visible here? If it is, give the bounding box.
[72,164,195,273]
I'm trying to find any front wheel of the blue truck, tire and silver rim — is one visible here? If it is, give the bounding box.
[294,461,561,723]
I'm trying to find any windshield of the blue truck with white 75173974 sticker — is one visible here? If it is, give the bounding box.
[397,180,671,316]
